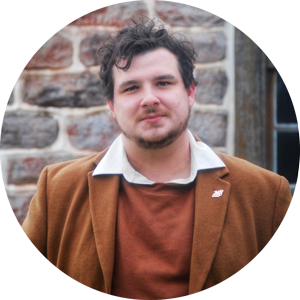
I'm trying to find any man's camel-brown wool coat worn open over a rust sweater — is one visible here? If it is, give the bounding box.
[0,151,298,300]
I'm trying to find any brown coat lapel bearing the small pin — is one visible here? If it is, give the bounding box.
[189,168,230,300]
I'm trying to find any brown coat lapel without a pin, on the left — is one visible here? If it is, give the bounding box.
[88,172,120,299]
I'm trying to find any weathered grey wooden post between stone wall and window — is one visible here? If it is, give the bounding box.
[235,0,268,167]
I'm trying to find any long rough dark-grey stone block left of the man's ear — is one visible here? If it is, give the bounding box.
[23,72,106,107]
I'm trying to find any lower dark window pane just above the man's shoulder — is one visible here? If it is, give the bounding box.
[277,132,299,183]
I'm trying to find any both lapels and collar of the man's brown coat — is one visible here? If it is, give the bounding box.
[88,145,230,300]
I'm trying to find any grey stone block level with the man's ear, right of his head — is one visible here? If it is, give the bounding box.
[196,69,228,105]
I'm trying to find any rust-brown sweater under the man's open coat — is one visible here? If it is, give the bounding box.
[112,178,195,300]
